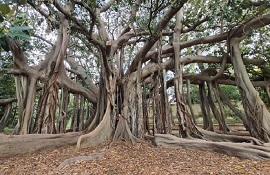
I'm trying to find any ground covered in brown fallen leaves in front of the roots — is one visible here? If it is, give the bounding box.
[0,142,270,175]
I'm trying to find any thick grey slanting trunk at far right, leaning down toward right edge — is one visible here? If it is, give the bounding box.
[230,38,270,142]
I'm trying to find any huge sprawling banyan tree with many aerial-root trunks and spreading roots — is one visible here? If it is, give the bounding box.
[0,0,270,159]
